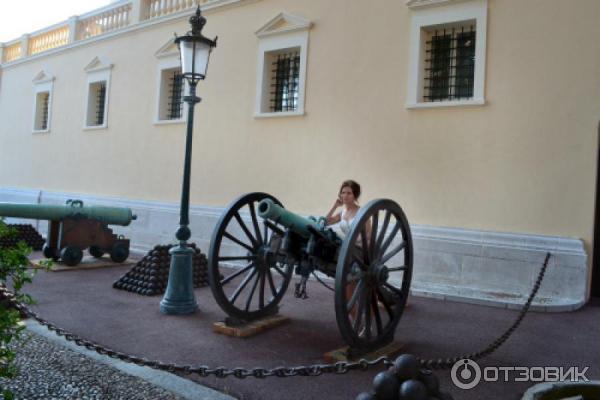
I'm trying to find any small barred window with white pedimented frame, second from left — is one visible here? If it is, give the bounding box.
[84,57,112,129]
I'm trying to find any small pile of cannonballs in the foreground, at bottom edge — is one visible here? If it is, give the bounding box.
[356,354,453,400]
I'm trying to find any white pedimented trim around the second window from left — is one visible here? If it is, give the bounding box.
[83,56,113,130]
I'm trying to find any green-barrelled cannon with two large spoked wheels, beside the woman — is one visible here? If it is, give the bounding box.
[208,193,413,352]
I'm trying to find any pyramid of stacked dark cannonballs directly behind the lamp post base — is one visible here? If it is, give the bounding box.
[113,243,208,296]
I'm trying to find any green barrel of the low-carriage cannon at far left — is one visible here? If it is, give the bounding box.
[0,200,137,226]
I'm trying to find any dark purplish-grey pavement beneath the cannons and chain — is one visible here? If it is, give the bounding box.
[12,258,600,400]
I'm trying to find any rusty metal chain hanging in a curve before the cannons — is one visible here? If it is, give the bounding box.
[0,253,550,379]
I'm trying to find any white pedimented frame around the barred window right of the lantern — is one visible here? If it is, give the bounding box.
[254,12,312,118]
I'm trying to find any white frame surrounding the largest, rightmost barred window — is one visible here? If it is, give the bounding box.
[406,0,488,109]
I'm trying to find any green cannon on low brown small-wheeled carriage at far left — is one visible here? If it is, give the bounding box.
[0,200,137,266]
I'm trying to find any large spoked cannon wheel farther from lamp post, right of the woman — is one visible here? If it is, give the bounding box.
[335,199,413,350]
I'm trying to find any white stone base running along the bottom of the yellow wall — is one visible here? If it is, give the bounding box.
[0,187,589,312]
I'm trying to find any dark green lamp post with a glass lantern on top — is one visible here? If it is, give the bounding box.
[160,6,217,314]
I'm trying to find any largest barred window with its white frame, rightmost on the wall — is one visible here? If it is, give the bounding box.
[406,0,487,108]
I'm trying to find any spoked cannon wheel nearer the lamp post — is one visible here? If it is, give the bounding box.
[208,192,293,321]
